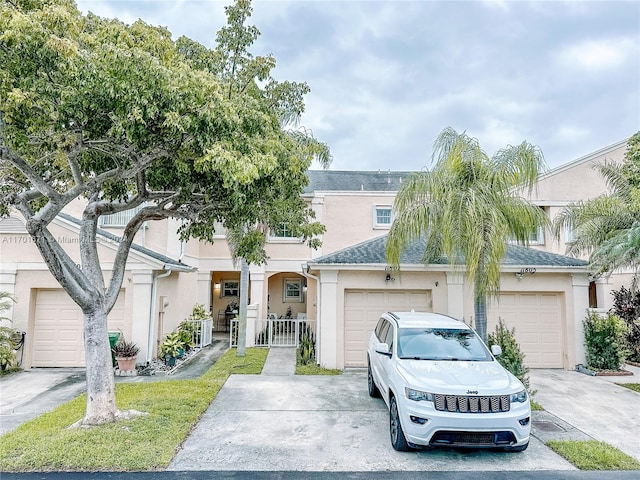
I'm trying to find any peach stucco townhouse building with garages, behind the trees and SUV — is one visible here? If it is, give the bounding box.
[0,141,626,368]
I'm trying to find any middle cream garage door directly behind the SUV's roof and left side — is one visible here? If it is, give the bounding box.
[344,290,433,367]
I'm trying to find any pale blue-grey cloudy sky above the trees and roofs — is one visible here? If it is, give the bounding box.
[77,0,640,170]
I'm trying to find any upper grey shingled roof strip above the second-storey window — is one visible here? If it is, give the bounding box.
[304,170,413,194]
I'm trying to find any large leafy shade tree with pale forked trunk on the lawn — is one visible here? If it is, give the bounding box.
[0,0,328,424]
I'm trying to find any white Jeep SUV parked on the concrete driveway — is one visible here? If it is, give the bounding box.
[367,312,531,451]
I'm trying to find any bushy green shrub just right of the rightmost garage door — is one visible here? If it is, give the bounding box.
[582,311,627,370]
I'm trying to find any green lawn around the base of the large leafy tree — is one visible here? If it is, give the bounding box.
[0,348,268,472]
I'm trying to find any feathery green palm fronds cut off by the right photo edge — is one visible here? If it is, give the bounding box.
[553,132,640,275]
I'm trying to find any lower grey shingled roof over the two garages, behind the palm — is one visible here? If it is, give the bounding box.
[309,235,588,268]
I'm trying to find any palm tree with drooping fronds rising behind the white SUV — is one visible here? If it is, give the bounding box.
[387,128,547,341]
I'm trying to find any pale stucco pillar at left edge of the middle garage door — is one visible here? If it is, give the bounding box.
[316,271,344,368]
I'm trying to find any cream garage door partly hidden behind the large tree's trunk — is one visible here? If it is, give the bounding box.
[32,289,130,367]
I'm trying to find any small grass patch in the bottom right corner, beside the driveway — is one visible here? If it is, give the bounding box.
[546,440,640,470]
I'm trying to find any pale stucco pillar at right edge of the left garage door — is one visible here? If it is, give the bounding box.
[131,270,157,363]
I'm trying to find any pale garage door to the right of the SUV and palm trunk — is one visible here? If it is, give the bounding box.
[487,292,564,368]
